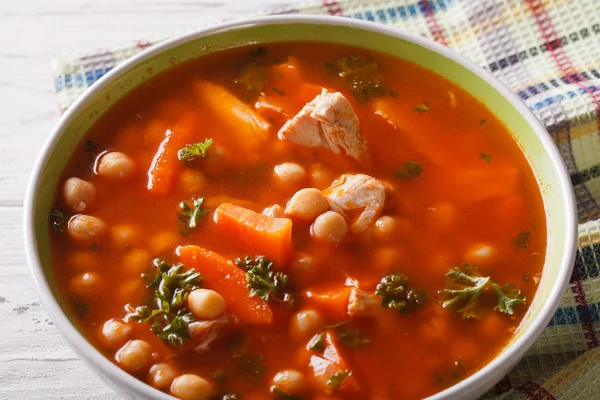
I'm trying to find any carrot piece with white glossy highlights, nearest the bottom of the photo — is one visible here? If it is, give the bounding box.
[309,332,359,394]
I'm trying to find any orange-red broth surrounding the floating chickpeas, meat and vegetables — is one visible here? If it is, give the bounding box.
[51,43,546,400]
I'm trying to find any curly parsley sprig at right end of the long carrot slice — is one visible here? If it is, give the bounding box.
[235,256,294,307]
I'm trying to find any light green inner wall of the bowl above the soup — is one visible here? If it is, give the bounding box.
[30,21,572,400]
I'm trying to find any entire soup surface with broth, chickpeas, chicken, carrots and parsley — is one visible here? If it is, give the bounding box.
[50,43,546,400]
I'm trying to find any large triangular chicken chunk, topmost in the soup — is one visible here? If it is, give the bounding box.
[278,89,367,160]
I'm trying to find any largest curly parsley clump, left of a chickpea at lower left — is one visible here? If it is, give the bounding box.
[130,258,202,346]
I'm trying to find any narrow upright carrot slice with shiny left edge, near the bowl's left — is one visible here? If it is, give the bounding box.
[147,112,199,195]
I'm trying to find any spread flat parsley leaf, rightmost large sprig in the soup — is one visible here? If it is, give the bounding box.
[440,263,525,318]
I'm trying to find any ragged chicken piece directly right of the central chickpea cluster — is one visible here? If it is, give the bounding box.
[323,174,392,233]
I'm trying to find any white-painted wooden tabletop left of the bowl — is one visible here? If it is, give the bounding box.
[0,0,290,399]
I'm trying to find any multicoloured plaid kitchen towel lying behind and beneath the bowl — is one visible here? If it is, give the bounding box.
[53,0,600,399]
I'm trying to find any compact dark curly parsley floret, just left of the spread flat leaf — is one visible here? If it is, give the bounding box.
[375,274,427,314]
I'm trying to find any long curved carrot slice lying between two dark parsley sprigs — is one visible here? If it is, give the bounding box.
[179,246,273,324]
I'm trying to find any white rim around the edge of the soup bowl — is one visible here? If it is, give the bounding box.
[23,15,577,400]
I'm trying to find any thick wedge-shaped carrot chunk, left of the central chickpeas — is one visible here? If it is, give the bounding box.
[215,203,292,268]
